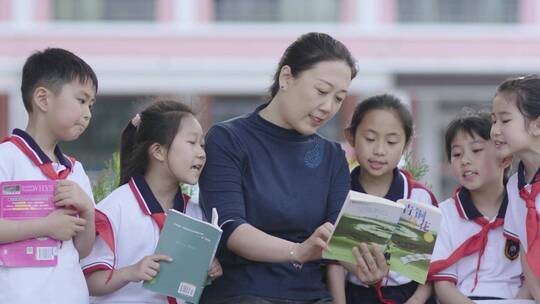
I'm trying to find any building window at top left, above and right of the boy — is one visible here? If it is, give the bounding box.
[53,0,157,21]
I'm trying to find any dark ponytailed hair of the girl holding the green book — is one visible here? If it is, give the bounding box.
[120,100,193,185]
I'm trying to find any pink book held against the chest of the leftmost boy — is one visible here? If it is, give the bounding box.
[0,180,60,267]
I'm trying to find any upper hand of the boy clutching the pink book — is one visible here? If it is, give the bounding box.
[54,180,94,213]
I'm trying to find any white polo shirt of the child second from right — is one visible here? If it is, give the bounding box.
[432,188,521,299]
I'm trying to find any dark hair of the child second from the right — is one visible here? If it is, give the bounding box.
[444,108,491,161]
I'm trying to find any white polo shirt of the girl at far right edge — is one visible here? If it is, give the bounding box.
[504,163,540,253]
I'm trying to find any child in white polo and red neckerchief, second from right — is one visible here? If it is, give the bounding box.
[429,112,521,303]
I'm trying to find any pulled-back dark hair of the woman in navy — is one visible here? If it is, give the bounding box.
[270,33,357,99]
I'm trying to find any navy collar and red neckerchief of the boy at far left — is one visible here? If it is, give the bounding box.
[2,129,75,180]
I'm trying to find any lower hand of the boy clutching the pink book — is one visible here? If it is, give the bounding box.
[45,208,86,241]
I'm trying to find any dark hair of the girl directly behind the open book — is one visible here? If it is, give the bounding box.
[347,94,413,146]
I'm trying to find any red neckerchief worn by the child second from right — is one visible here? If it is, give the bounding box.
[428,188,504,292]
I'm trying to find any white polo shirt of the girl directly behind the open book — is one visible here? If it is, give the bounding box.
[347,167,437,287]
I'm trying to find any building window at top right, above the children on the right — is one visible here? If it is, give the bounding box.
[397,0,519,23]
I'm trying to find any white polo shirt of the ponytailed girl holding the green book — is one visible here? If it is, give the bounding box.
[81,176,203,304]
